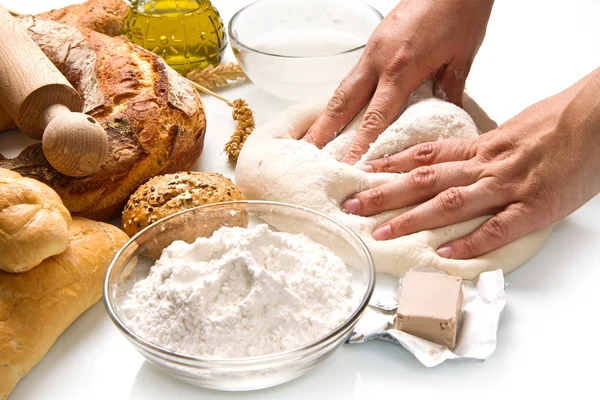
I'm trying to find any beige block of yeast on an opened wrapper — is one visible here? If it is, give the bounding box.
[395,271,463,349]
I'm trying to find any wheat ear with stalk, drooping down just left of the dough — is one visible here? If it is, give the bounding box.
[189,80,255,163]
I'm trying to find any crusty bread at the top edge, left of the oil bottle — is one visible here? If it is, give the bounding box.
[37,0,129,36]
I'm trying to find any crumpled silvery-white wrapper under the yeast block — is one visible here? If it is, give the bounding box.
[348,267,506,367]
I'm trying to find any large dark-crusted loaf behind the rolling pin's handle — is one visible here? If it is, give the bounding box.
[0,17,206,220]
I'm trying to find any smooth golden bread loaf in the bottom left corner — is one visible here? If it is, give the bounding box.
[0,218,127,399]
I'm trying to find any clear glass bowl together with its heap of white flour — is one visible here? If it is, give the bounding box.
[104,201,375,391]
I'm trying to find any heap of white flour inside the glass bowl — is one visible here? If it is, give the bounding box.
[123,225,352,358]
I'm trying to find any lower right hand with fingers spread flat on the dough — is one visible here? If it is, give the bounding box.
[342,68,600,259]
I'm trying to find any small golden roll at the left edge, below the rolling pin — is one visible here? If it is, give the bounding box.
[0,168,71,272]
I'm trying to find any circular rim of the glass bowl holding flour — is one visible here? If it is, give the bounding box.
[102,200,375,367]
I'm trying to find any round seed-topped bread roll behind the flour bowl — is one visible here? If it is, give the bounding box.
[123,172,244,236]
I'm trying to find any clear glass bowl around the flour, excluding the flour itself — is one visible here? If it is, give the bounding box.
[103,201,375,391]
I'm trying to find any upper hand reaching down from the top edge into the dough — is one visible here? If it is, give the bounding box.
[303,0,493,164]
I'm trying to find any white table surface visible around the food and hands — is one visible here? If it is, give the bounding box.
[0,0,600,400]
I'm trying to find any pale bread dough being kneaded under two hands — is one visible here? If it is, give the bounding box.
[235,82,552,279]
